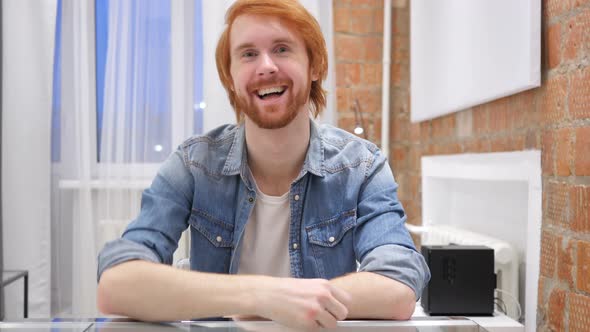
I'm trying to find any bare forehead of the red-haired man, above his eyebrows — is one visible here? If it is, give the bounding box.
[229,14,303,50]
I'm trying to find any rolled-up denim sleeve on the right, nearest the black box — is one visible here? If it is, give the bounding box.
[354,152,430,300]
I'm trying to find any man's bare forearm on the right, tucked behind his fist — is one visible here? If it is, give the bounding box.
[330,272,416,320]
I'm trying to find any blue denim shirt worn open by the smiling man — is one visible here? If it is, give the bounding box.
[98,120,430,298]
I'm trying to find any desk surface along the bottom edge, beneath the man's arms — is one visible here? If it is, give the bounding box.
[0,317,522,332]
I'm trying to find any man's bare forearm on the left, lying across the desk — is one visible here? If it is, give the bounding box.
[97,260,260,321]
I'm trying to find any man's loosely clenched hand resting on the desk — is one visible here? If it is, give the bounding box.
[255,278,351,330]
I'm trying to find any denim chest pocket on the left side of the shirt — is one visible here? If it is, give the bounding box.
[189,209,234,248]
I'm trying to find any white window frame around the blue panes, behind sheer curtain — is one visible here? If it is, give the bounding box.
[53,0,199,187]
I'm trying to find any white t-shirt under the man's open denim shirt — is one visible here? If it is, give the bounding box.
[238,189,291,277]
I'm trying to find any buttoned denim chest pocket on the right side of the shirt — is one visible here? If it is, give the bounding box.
[305,210,356,279]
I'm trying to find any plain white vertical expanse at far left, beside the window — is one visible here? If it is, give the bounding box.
[2,0,56,320]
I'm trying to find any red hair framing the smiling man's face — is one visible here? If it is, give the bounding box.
[215,0,328,122]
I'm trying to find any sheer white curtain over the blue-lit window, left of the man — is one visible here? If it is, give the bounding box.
[53,0,187,317]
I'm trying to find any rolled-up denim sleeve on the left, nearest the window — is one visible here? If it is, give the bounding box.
[97,148,194,280]
